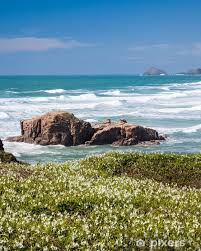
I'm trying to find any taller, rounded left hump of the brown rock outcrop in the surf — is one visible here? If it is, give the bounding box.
[7,111,94,146]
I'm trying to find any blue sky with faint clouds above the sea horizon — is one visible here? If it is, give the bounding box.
[0,0,201,75]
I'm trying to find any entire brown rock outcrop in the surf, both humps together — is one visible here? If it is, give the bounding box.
[7,112,164,146]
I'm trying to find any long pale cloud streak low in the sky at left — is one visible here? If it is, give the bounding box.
[0,37,92,52]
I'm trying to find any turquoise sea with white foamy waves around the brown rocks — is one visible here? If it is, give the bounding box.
[0,76,201,162]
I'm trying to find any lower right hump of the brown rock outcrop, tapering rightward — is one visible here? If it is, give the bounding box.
[86,120,164,146]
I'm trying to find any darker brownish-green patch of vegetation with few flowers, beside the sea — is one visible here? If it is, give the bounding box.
[80,152,201,188]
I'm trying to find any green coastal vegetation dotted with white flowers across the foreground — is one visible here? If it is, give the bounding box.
[0,152,201,250]
